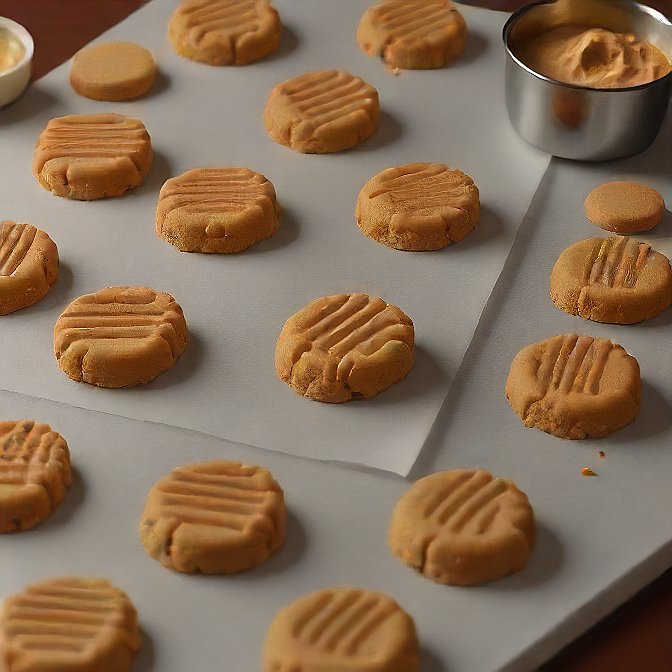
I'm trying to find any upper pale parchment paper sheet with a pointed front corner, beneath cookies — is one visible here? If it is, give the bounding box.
[0,0,548,474]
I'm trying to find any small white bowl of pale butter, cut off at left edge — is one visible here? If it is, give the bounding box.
[0,16,34,107]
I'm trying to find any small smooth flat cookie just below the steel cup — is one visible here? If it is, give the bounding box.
[583,182,665,233]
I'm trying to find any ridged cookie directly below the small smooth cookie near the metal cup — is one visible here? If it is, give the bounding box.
[551,236,672,324]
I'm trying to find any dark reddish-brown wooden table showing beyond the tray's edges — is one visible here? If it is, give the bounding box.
[0,0,672,672]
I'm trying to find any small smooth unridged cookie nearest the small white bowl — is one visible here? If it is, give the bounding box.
[70,42,156,101]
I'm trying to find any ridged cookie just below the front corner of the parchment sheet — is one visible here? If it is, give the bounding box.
[388,469,536,586]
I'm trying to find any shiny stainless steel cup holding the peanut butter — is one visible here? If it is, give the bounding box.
[503,0,672,161]
